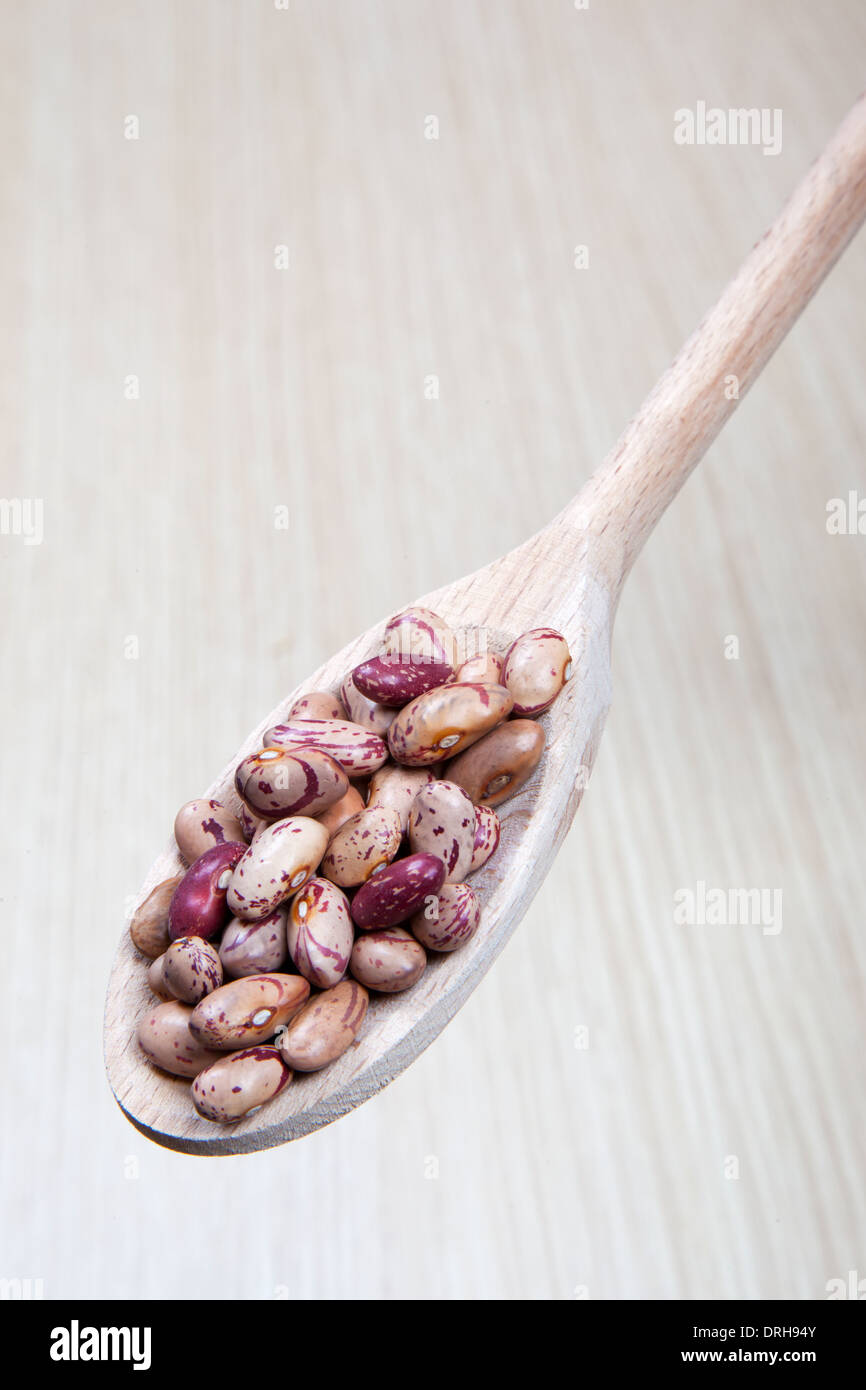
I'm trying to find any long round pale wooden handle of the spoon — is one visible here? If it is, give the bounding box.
[567,93,866,600]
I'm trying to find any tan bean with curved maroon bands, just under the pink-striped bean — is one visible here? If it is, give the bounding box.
[235,748,349,820]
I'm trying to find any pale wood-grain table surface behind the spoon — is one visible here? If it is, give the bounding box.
[0,0,866,1298]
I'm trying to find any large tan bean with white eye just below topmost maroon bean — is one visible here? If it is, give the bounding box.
[388,681,513,767]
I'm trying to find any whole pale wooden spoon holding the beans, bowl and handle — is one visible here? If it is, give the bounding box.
[104,96,866,1154]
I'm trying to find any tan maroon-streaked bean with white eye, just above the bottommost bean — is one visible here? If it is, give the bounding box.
[189,974,310,1052]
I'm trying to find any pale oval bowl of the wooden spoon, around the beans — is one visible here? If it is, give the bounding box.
[106,532,612,1154]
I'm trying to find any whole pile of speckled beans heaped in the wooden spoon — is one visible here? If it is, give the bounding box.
[129,607,571,1123]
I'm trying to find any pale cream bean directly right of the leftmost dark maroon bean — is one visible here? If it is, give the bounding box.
[228,816,328,922]
